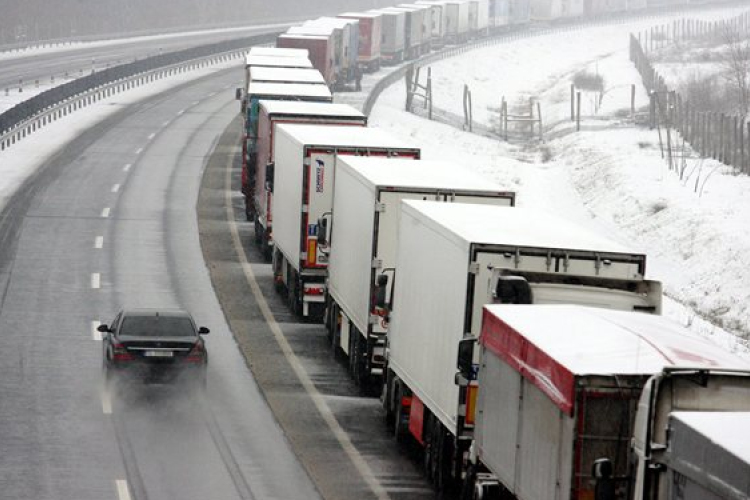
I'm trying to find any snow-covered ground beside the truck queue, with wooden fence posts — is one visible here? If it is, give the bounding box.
[370,4,750,352]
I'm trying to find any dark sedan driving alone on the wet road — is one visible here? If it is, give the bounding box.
[99,309,209,387]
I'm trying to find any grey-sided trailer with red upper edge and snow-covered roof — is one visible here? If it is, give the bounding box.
[470,305,750,500]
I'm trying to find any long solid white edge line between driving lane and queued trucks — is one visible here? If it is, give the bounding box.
[224,145,390,500]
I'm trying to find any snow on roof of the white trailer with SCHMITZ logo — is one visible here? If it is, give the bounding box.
[277,124,419,151]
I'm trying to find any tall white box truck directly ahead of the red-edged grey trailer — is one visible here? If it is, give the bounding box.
[388,200,661,488]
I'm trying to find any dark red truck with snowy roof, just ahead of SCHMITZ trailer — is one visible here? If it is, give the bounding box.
[250,100,367,260]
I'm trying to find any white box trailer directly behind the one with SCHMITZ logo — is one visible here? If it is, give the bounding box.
[326,156,515,388]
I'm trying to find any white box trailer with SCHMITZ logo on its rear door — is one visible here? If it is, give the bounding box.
[267,125,420,317]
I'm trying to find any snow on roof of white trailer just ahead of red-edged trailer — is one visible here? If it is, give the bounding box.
[404,201,642,255]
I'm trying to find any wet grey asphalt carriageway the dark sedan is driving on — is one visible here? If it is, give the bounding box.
[0,62,434,500]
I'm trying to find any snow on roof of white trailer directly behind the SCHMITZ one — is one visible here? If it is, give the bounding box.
[342,156,507,193]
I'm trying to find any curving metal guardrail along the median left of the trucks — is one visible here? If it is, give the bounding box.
[0,33,277,150]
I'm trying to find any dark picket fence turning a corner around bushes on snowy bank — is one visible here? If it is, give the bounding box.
[630,12,750,174]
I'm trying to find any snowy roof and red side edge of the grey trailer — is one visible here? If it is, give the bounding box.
[480,306,750,414]
